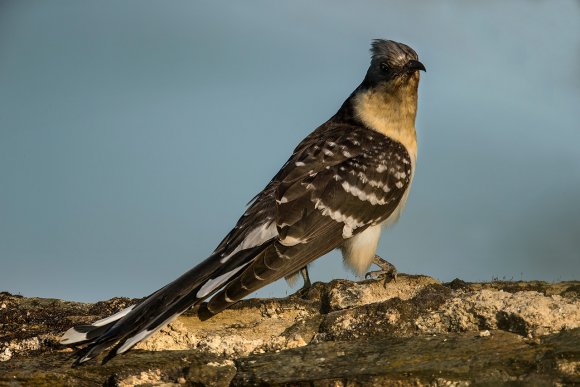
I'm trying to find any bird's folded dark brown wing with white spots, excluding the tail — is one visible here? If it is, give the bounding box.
[207,124,412,313]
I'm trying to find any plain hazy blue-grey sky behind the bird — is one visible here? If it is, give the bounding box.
[0,0,580,301]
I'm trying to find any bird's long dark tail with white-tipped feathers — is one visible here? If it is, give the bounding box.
[61,246,264,365]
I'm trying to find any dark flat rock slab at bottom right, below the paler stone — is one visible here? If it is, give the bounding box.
[233,330,580,386]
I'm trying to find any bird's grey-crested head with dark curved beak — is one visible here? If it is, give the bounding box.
[363,39,426,91]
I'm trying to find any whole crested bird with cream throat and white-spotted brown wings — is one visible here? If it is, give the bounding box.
[60,39,426,365]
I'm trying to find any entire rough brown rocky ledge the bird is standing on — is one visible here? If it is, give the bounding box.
[0,275,580,386]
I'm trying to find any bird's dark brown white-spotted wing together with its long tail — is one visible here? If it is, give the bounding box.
[62,124,411,363]
